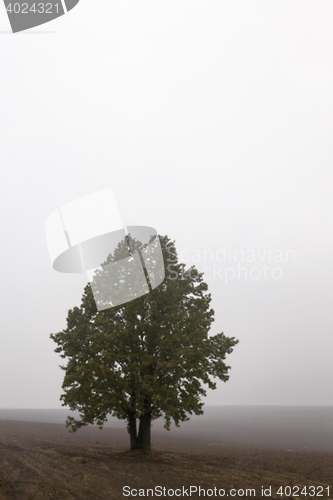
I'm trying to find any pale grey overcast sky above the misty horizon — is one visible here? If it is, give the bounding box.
[0,0,333,408]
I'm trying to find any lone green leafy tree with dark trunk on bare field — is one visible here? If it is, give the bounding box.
[51,236,238,451]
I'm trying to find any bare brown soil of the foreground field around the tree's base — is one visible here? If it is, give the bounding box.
[0,420,333,500]
